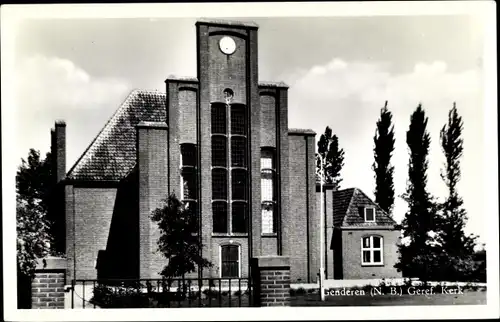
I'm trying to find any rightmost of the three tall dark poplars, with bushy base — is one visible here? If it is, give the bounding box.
[439,103,477,279]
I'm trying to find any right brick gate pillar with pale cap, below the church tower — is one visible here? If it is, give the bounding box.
[251,256,290,306]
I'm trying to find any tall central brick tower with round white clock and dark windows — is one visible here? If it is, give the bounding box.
[196,20,261,276]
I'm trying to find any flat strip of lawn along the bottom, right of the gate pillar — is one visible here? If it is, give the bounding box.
[291,290,486,306]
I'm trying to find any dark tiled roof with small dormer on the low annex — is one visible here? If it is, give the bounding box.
[332,188,396,228]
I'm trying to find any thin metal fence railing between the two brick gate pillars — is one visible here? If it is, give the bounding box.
[71,278,253,309]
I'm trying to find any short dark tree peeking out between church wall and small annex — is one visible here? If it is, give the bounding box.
[316,126,344,188]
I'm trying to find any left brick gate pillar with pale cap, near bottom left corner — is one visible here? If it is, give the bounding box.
[31,257,66,309]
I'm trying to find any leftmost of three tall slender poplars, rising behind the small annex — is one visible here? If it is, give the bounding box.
[372,101,396,215]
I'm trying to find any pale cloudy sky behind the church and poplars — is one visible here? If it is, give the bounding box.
[6,5,497,242]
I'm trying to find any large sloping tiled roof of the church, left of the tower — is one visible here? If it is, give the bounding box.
[66,90,166,181]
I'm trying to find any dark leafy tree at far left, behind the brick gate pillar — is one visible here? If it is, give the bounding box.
[16,149,53,277]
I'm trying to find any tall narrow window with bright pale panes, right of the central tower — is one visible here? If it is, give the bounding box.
[260,148,277,234]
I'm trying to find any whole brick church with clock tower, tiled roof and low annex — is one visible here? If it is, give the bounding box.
[52,20,399,283]
